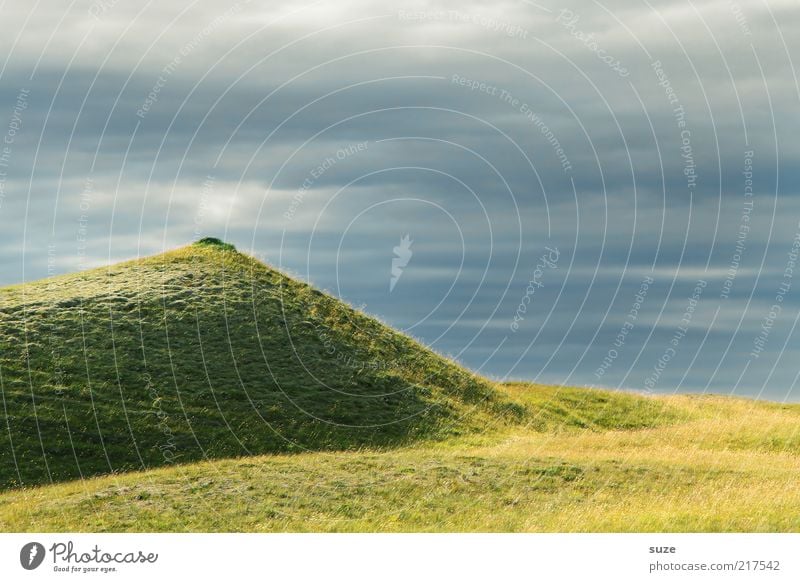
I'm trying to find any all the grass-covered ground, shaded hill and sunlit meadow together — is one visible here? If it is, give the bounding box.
[0,240,800,532]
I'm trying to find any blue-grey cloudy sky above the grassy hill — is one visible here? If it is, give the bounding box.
[0,0,800,402]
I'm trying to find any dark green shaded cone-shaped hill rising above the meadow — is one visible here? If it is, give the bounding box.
[0,240,523,489]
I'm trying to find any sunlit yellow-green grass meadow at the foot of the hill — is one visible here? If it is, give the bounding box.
[0,385,800,532]
